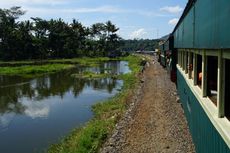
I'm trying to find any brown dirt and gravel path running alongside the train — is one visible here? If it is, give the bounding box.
[101,56,194,153]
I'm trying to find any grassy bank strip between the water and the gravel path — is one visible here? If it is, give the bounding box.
[48,56,141,153]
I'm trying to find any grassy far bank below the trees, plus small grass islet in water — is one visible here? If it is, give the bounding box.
[0,57,132,78]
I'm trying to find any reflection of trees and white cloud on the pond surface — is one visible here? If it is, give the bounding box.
[0,61,130,127]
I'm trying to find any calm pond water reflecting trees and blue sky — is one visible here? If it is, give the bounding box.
[0,61,130,153]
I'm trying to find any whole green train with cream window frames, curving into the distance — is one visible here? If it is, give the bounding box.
[158,0,230,153]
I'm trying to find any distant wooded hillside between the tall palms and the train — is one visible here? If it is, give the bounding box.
[120,39,159,51]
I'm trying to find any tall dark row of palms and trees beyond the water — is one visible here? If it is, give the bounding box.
[0,7,121,60]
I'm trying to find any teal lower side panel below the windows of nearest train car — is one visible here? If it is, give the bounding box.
[177,70,230,153]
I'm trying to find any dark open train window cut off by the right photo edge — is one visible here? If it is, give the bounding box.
[224,59,230,120]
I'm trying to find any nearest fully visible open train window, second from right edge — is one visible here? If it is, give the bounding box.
[207,56,218,105]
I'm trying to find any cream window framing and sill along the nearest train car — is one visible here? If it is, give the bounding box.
[177,49,230,147]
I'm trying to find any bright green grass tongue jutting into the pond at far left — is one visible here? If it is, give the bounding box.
[0,64,74,76]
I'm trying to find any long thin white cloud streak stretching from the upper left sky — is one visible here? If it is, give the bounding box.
[0,0,174,20]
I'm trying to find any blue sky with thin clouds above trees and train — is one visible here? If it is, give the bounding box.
[0,0,188,39]
